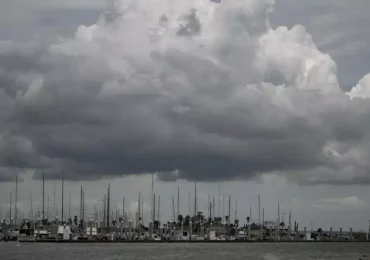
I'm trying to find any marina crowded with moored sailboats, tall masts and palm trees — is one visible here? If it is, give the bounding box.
[0,175,369,243]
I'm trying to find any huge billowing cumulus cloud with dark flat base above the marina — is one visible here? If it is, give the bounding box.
[0,0,370,184]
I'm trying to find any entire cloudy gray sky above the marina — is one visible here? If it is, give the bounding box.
[0,0,370,230]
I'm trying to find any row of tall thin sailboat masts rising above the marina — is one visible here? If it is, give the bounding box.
[2,174,294,232]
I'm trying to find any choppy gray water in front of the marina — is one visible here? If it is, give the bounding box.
[0,242,370,260]
